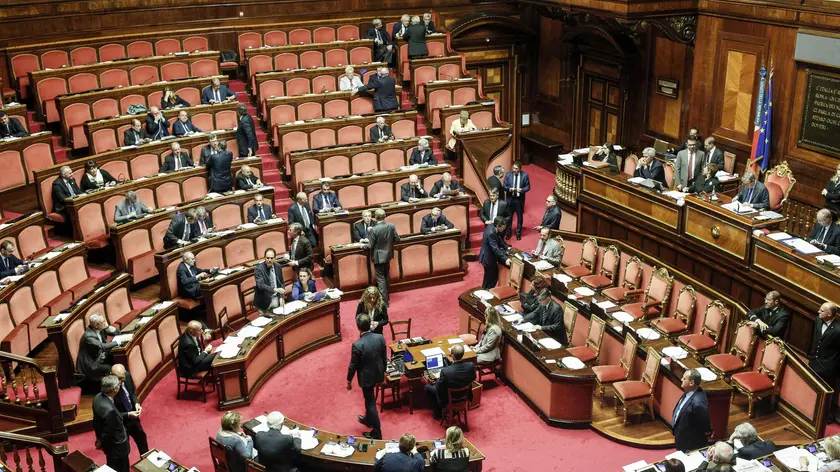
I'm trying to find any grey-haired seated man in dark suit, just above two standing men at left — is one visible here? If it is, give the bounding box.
[76,313,121,382]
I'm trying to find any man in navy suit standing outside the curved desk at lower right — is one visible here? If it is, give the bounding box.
[671,369,712,451]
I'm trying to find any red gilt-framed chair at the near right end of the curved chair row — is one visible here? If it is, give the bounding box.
[732,337,786,418]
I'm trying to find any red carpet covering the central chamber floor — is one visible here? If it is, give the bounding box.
[60,166,670,472]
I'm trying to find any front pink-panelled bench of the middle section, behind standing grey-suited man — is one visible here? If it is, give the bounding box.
[331,228,467,297]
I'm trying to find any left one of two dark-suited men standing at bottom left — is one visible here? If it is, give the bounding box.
[93,375,131,472]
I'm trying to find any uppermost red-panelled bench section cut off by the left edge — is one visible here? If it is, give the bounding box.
[0,131,55,193]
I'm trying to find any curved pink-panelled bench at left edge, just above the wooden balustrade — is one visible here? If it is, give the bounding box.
[0,243,96,356]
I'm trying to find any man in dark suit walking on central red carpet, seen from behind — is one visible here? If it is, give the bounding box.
[347,313,388,439]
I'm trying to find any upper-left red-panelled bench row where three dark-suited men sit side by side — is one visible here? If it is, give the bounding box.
[83,100,239,154]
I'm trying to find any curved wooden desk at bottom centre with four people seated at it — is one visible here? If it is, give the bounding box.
[242,417,484,472]
